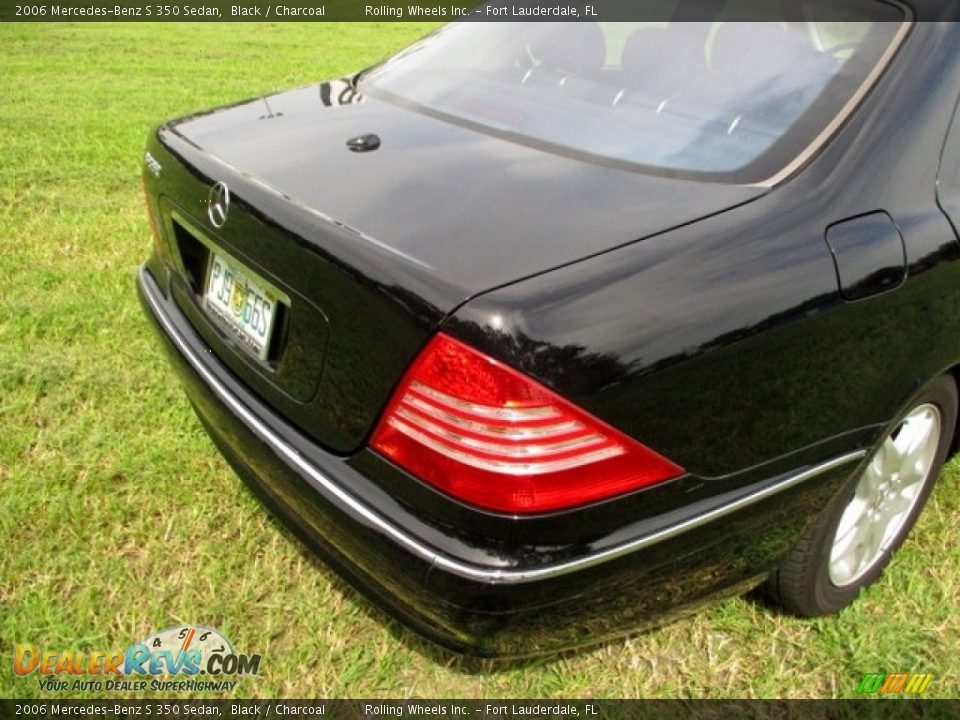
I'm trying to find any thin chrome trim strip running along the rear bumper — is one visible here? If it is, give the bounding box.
[139,267,866,585]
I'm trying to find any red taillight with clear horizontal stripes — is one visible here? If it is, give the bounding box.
[370,333,683,513]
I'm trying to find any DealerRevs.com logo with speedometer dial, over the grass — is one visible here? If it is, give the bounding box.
[13,625,261,692]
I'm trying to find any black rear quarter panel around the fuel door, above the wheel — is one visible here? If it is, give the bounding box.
[447,23,960,478]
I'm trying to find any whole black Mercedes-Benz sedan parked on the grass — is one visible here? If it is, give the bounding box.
[139,0,960,656]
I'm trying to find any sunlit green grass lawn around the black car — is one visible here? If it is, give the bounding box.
[0,24,960,698]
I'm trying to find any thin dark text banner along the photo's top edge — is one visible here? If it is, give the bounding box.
[0,0,960,22]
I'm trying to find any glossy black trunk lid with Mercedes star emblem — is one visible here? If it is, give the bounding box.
[148,83,763,452]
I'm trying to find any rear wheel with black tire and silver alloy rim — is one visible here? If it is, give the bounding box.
[765,376,957,617]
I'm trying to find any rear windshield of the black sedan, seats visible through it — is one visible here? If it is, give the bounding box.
[362,0,905,183]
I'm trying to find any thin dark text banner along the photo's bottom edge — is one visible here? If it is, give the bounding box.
[0,698,960,720]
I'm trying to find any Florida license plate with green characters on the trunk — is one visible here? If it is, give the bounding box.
[203,251,279,360]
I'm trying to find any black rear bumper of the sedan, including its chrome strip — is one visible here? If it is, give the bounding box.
[138,268,864,656]
